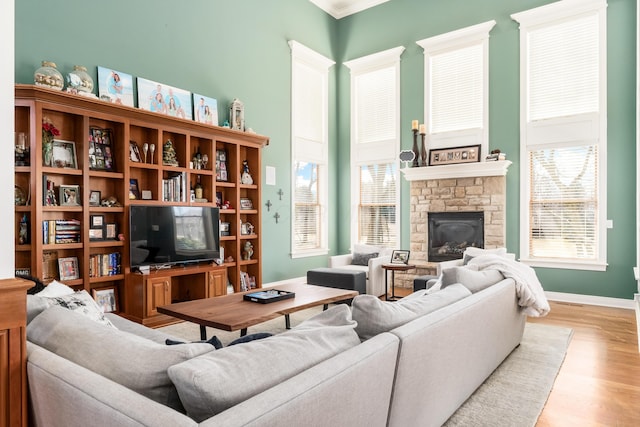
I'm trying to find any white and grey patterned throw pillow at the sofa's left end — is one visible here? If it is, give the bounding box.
[27,290,115,328]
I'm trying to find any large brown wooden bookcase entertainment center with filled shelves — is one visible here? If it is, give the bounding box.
[15,84,269,326]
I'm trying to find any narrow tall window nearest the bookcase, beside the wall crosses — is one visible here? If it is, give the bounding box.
[289,41,334,258]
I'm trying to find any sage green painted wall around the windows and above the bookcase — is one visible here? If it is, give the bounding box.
[15,0,636,298]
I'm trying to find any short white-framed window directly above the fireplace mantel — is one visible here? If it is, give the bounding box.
[417,21,496,153]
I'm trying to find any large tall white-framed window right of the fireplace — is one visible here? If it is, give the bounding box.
[512,0,607,270]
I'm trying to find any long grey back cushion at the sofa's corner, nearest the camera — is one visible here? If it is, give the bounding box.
[169,305,360,421]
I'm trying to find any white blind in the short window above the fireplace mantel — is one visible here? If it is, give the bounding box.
[428,43,484,133]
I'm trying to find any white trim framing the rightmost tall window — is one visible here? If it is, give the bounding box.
[511,0,608,271]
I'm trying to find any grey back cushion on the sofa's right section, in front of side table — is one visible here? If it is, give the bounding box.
[351,285,471,340]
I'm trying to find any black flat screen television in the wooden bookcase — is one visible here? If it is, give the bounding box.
[129,205,220,269]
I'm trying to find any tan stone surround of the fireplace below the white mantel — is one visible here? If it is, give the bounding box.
[395,176,507,288]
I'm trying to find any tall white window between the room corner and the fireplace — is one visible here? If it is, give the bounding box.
[345,47,404,248]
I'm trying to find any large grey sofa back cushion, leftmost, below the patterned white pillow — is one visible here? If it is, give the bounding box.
[27,306,214,411]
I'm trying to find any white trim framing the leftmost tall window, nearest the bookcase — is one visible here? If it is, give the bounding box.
[288,40,335,259]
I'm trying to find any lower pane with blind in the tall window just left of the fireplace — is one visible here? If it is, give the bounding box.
[358,163,398,248]
